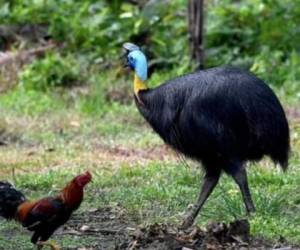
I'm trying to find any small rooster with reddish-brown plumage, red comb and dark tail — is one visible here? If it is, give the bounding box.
[0,171,92,249]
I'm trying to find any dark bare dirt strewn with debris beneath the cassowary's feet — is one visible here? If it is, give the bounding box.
[49,207,300,250]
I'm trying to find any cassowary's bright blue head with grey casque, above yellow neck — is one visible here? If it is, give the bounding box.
[123,43,148,81]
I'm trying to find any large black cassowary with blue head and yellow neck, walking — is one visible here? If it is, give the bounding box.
[123,43,290,228]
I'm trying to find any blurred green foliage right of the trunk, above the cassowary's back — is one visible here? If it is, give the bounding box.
[206,0,300,100]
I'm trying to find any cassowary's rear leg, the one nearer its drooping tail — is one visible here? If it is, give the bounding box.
[226,165,255,214]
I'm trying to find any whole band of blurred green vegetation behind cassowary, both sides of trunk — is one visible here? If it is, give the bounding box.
[0,0,300,102]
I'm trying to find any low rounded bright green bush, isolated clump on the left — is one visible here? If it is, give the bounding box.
[20,53,82,90]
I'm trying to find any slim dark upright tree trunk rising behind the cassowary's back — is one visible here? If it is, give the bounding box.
[188,0,204,69]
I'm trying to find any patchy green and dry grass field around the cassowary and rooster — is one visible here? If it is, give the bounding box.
[0,72,300,249]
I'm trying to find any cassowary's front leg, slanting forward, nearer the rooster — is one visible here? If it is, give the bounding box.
[181,171,221,229]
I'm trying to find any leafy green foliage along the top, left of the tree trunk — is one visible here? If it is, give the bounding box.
[0,0,187,66]
